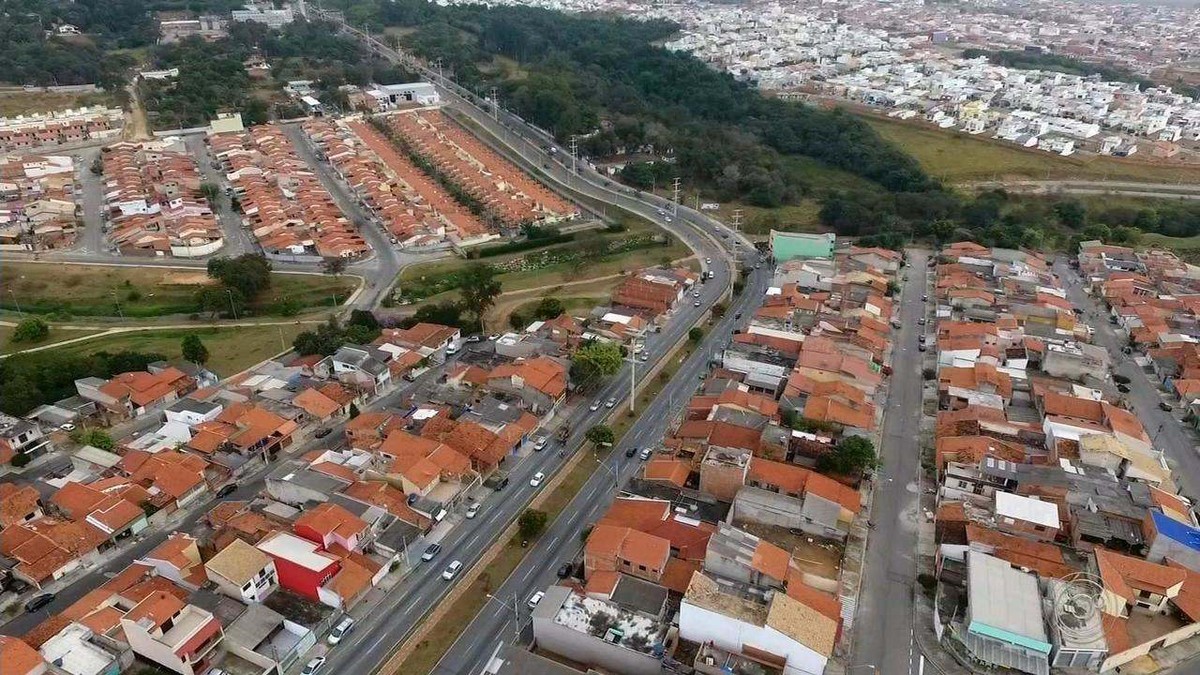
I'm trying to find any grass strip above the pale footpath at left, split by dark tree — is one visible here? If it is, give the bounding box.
[0,263,356,318]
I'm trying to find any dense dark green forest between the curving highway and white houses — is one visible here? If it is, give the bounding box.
[331,0,937,207]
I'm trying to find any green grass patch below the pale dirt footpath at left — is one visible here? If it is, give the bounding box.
[37,323,310,377]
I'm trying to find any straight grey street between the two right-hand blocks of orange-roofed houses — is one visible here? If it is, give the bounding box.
[850,250,929,675]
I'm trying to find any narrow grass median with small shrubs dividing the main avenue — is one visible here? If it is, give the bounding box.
[386,329,696,675]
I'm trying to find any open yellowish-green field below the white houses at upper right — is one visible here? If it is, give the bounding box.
[862,115,1200,183]
